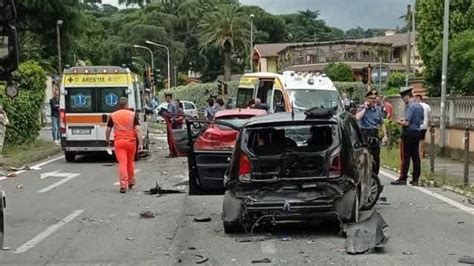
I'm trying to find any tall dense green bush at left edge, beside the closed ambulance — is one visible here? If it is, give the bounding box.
[0,61,46,145]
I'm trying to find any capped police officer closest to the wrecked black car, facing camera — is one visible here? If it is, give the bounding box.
[355,89,387,179]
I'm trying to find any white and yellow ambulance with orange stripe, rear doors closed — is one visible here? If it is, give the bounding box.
[60,66,150,162]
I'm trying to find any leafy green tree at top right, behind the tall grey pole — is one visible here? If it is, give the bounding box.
[416,0,474,94]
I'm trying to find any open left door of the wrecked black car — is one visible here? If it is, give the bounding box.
[186,119,240,195]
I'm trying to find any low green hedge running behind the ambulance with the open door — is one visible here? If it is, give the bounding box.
[158,81,367,109]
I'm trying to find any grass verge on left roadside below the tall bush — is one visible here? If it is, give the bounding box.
[3,139,61,167]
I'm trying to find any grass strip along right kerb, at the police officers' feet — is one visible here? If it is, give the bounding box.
[380,147,474,193]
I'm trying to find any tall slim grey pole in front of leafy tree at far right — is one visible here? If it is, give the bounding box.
[439,0,449,152]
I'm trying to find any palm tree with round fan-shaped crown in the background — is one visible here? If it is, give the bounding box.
[199,5,250,81]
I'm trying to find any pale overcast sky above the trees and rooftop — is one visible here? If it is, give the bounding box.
[102,0,414,30]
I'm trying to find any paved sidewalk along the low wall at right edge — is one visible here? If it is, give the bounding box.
[423,157,474,185]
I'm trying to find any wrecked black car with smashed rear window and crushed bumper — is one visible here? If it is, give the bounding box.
[223,108,372,233]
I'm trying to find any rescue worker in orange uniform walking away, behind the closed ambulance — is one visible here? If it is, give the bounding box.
[105,97,143,193]
